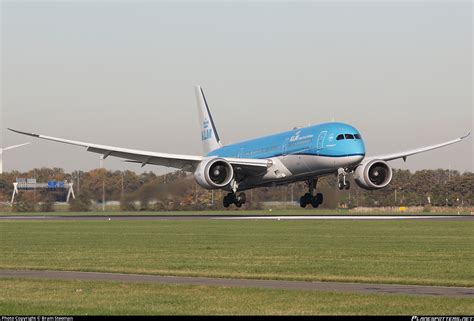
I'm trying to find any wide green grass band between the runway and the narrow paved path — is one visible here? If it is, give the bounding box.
[0,219,474,286]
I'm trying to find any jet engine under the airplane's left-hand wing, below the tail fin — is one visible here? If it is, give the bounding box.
[194,158,234,189]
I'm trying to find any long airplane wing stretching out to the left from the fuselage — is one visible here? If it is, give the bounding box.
[8,128,271,175]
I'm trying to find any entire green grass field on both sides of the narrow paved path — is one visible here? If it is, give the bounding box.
[0,219,474,315]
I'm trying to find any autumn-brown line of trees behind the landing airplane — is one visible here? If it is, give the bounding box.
[0,168,474,211]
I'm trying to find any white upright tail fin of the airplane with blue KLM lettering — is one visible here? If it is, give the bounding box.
[194,86,222,154]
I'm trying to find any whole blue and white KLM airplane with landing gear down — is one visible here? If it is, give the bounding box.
[9,86,470,208]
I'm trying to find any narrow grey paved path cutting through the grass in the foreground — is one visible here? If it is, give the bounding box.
[0,270,474,298]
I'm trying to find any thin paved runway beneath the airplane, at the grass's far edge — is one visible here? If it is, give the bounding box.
[0,215,474,221]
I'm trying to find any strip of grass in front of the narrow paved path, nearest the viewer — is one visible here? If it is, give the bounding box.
[0,279,474,315]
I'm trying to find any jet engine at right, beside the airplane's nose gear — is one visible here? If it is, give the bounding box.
[354,159,392,190]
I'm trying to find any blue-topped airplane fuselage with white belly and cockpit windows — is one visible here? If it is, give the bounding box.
[207,122,365,190]
